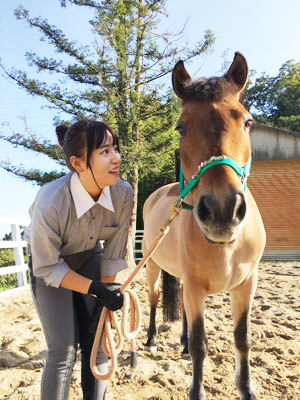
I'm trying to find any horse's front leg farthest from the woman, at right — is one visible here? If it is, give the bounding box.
[231,271,257,400]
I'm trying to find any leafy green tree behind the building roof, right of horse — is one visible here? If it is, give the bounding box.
[244,60,300,132]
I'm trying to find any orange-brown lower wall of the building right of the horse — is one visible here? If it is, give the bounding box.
[248,160,300,252]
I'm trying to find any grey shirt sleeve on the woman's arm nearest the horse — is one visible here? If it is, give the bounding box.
[101,187,133,276]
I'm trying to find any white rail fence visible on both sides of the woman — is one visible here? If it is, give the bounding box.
[0,217,143,297]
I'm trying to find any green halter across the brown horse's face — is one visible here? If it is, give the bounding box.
[178,156,252,210]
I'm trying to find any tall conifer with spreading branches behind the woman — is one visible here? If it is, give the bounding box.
[1,0,214,260]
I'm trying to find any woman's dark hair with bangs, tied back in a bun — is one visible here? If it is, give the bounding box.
[56,119,119,170]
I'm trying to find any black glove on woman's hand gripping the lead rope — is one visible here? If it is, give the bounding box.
[88,281,124,311]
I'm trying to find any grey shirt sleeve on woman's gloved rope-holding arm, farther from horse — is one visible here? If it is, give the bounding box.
[30,206,70,287]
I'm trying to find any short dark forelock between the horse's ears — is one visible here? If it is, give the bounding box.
[183,76,236,101]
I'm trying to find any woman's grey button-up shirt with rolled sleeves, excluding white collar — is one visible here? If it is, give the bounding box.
[25,174,133,287]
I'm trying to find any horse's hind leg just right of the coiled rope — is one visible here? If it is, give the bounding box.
[144,259,161,351]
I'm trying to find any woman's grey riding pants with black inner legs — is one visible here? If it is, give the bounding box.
[28,255,108,400]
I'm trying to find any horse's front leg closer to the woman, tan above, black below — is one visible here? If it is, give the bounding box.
[183,279,207,400]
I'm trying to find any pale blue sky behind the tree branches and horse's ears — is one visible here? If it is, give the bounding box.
[0,0,300,239]
